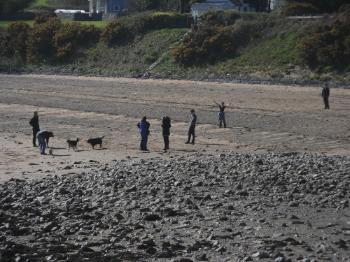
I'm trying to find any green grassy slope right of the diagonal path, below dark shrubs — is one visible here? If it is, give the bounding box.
[153,25,302,79]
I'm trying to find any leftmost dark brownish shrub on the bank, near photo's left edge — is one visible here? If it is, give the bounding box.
[5,22,31,61]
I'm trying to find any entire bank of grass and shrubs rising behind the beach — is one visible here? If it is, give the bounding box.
[0,6,350,81]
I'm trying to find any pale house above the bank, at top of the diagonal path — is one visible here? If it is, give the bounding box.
[191,0,255,20]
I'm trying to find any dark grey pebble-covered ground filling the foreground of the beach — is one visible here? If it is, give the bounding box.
[0,153,350,262]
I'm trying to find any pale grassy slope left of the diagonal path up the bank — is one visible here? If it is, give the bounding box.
[21,28,188,77]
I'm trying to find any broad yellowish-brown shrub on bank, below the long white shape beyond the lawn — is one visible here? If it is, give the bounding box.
[53,23,100,61]
